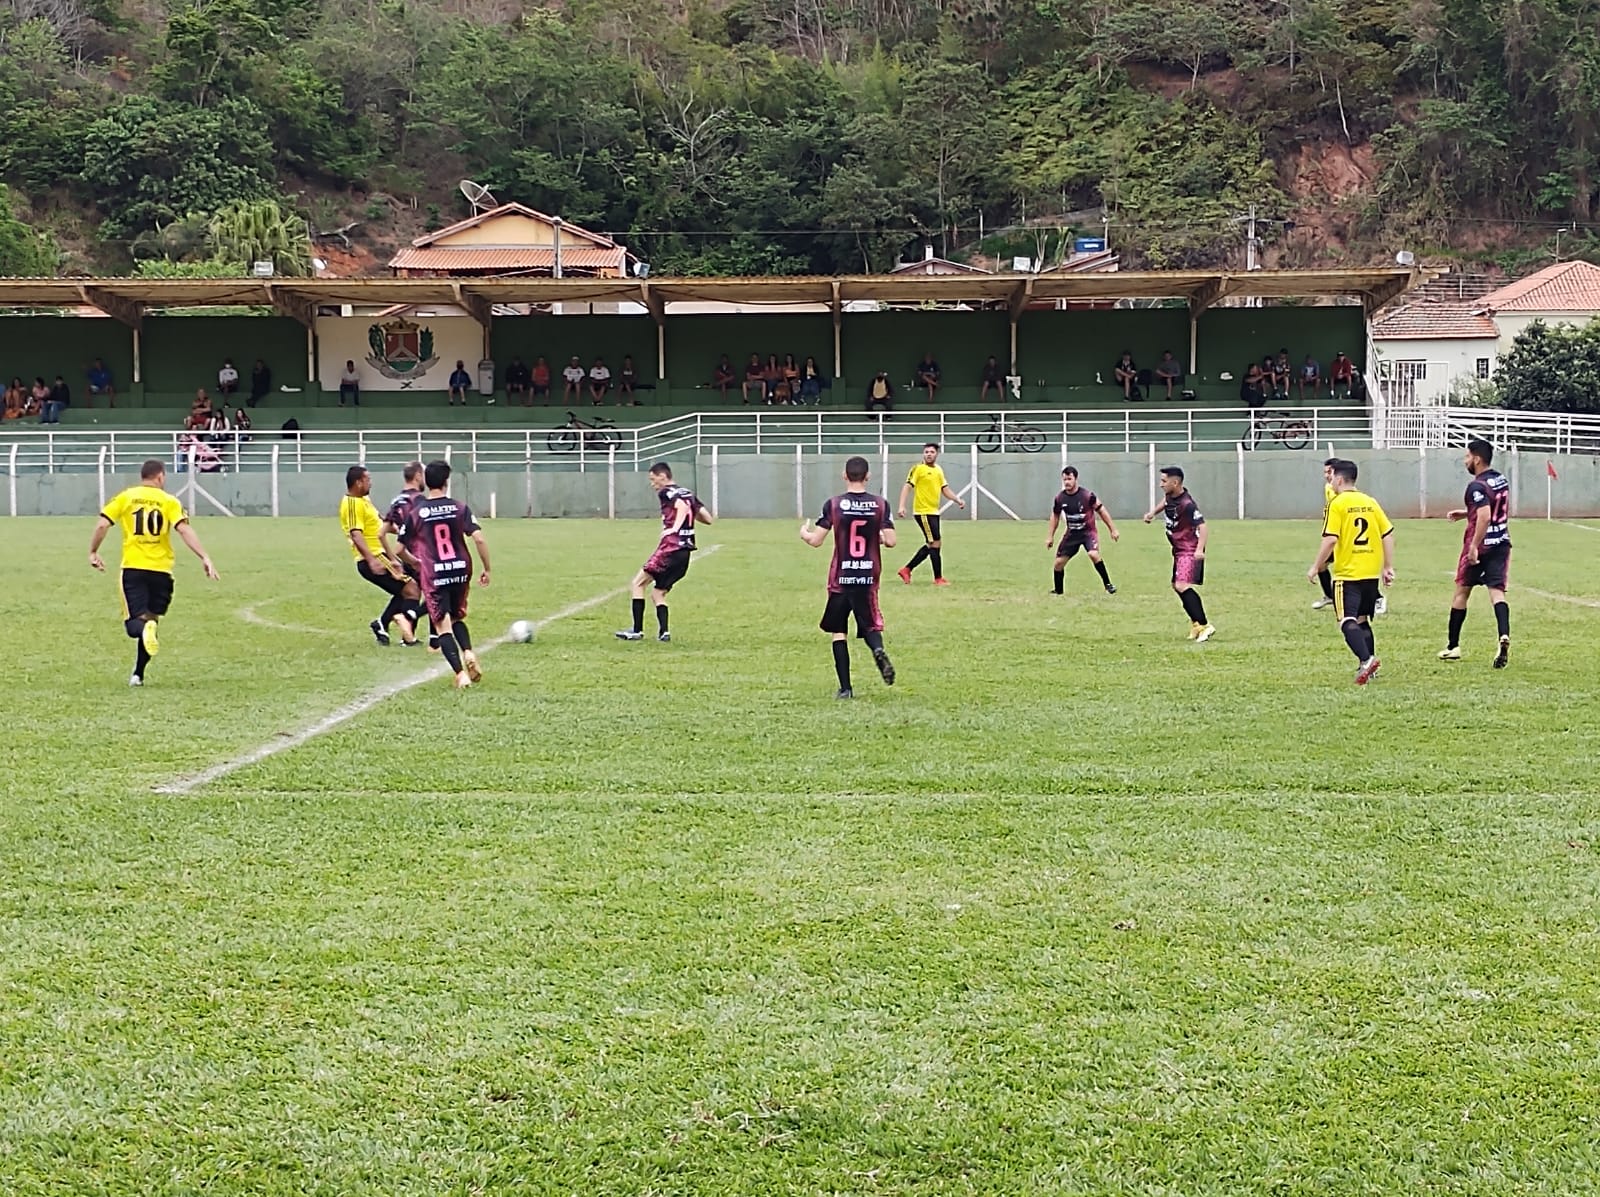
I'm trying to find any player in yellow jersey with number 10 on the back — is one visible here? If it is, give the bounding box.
[90,458,218,687]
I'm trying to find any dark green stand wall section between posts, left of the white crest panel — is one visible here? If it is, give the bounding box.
[139,315,306,395]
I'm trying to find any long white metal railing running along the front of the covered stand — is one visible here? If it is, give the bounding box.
[0,402,1373,474]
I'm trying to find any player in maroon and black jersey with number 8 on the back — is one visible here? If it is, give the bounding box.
[403,461,490,690]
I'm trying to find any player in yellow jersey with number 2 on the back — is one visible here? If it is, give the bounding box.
[1306,461,1395,687]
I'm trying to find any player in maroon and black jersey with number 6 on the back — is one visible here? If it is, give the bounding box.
[800,458,894,698]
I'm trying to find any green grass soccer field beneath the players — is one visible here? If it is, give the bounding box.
[0,514,1600,1197]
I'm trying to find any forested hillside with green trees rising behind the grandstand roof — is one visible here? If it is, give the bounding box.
[0,0,1600,274]
